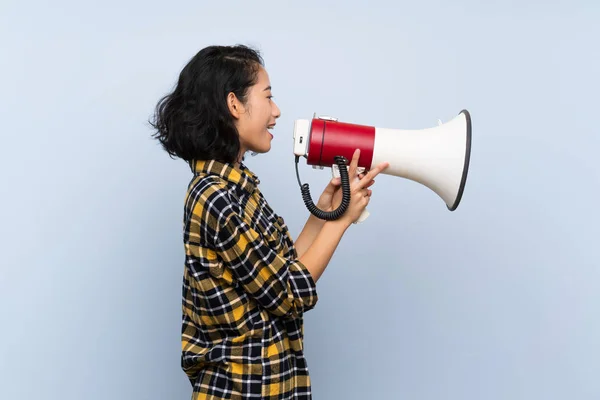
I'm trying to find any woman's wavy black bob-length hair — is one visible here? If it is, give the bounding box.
[150,45,264,163]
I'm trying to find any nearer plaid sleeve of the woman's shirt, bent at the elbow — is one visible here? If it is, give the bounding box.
[215,208,318,318]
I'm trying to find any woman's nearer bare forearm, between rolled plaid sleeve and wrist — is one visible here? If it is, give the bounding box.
[299,220,348,282]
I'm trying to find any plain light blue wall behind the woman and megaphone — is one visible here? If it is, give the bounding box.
[0,0,600,400]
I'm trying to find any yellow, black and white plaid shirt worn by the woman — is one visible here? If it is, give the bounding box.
[181,160,317,399]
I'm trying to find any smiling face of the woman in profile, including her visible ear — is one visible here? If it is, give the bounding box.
[228,67,281,158]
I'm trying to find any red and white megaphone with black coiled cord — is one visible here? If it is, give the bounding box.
[294,110,471,222]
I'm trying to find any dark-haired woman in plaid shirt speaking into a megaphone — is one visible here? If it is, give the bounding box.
[152,46,387,399]
